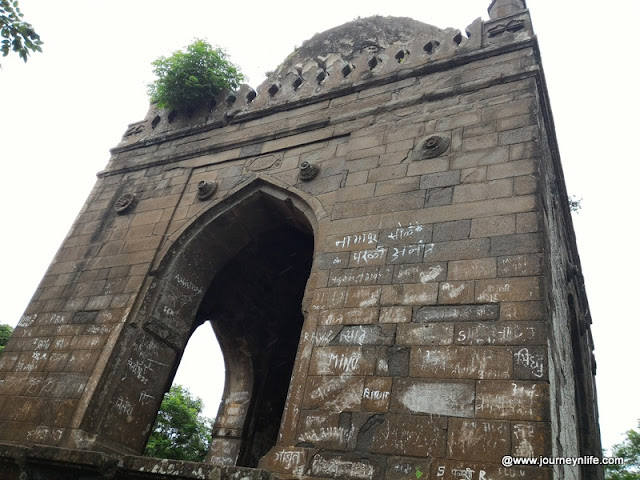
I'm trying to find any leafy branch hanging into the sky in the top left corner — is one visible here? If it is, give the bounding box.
[0,0,42,62]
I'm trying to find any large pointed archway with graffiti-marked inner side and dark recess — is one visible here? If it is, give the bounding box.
[84,177,324,466]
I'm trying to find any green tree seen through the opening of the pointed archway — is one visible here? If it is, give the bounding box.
[144,385,213,462]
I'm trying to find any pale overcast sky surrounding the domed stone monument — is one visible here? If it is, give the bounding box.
[0,0,640,447]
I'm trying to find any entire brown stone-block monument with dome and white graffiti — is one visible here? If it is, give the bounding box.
[0,1,601,480]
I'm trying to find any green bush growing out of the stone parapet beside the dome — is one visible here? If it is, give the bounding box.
[148,39,244,114]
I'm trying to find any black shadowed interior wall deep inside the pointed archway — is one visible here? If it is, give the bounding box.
[197,223,313,467]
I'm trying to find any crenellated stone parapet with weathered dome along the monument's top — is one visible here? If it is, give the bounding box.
[114,10,533,153]
